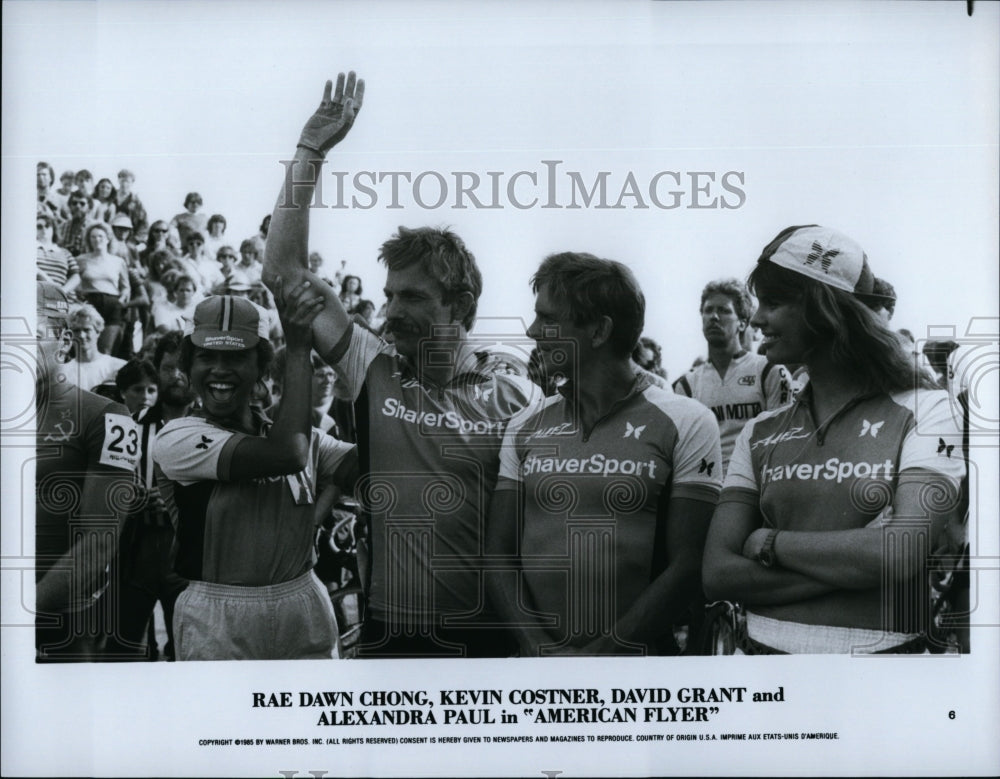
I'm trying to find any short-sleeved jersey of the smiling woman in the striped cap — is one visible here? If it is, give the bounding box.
[153,416,354,587]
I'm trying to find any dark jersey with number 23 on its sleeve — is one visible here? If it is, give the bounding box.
[35,381,139,610]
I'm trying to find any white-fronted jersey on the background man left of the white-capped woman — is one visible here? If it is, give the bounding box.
[673,352,792,473]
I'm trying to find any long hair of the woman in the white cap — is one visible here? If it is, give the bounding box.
[747,256,935,393]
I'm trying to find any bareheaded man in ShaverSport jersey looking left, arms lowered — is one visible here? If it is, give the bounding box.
[488,253,722,655]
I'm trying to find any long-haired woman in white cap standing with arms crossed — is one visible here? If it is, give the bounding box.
[703,225,964,653]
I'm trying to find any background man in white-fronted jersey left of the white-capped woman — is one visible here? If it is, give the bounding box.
[673,279,792,475]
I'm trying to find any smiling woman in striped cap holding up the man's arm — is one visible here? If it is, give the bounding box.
[153,282,357,660]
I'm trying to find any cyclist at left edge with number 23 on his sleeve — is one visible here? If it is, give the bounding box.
[35,282,140,662]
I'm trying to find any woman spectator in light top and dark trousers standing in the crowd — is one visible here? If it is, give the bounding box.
[76,222,132,354]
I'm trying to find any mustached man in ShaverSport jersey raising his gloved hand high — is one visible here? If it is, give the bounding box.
[263,73,533,657]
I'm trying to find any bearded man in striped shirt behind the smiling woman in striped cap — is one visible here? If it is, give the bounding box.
[108,330,194,660]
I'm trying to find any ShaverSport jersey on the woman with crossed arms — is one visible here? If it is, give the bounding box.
[720,385,965,633]
